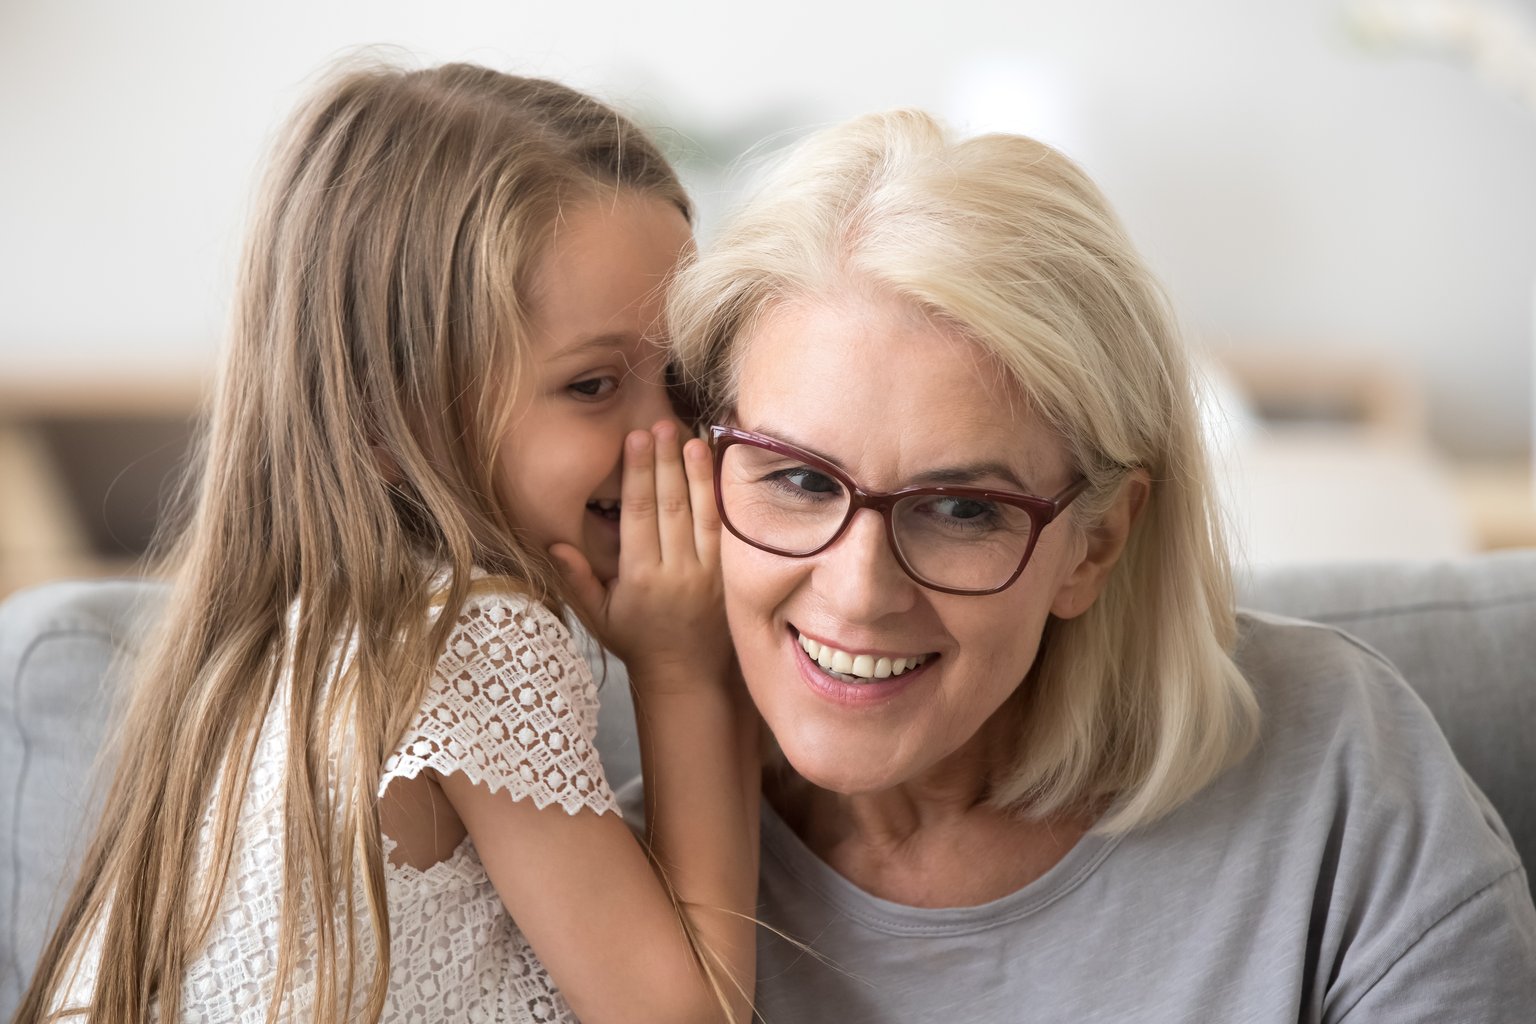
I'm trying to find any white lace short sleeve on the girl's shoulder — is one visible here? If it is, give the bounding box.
[379,594,619,814]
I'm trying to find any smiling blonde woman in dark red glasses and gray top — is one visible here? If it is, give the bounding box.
[670,112,1536,1024]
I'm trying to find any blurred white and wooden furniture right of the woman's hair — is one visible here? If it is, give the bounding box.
[1207,345,1536,567]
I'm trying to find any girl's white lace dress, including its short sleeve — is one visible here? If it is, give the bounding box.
[61,591,619,1024]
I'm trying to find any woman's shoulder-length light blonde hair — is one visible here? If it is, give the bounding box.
[668,111,1258,831]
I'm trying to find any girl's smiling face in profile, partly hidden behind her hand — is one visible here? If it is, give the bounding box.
[496,192,693,582]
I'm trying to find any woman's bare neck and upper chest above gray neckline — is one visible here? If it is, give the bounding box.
[763,765,1094,907]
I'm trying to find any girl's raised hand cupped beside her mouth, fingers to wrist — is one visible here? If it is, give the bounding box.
[550,421,731,691]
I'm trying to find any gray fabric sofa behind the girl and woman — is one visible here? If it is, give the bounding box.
[0,551,1536,1018]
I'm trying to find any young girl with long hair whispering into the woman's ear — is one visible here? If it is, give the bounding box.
[17,64,757,1024]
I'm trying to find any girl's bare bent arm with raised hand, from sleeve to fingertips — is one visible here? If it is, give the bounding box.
[438,424,757,1024]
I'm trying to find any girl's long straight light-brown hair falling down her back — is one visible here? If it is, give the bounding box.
[17,64,690,1024]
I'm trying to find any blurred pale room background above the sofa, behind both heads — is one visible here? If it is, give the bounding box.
[0,0,1536,594]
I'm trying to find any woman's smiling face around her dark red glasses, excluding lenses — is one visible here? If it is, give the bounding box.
[722,295,1086,794]
